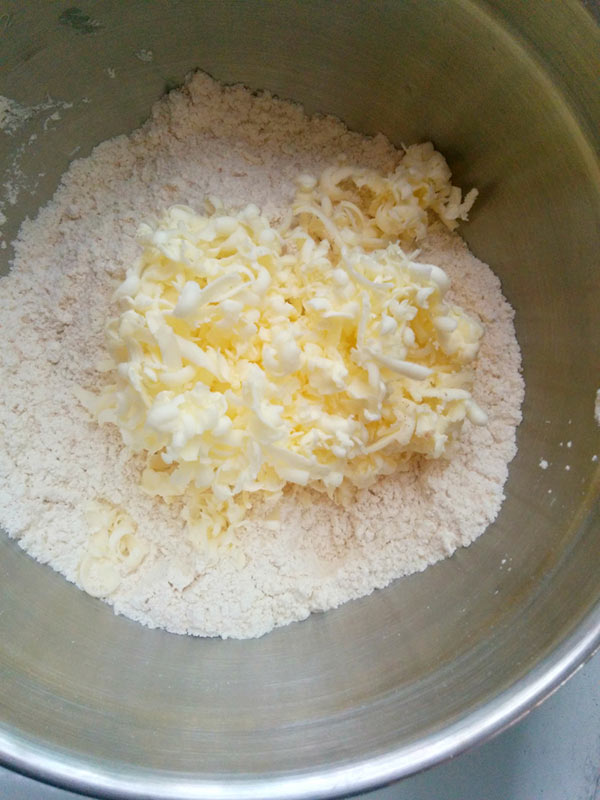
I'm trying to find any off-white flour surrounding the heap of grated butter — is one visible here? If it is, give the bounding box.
[0,75,523,637]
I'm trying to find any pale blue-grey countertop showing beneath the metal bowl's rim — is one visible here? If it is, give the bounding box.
[0,655,600,800]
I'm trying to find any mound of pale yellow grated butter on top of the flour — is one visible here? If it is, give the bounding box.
[79,145,486,545]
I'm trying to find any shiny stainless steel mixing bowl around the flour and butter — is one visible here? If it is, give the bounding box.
[0,0,600,800]
